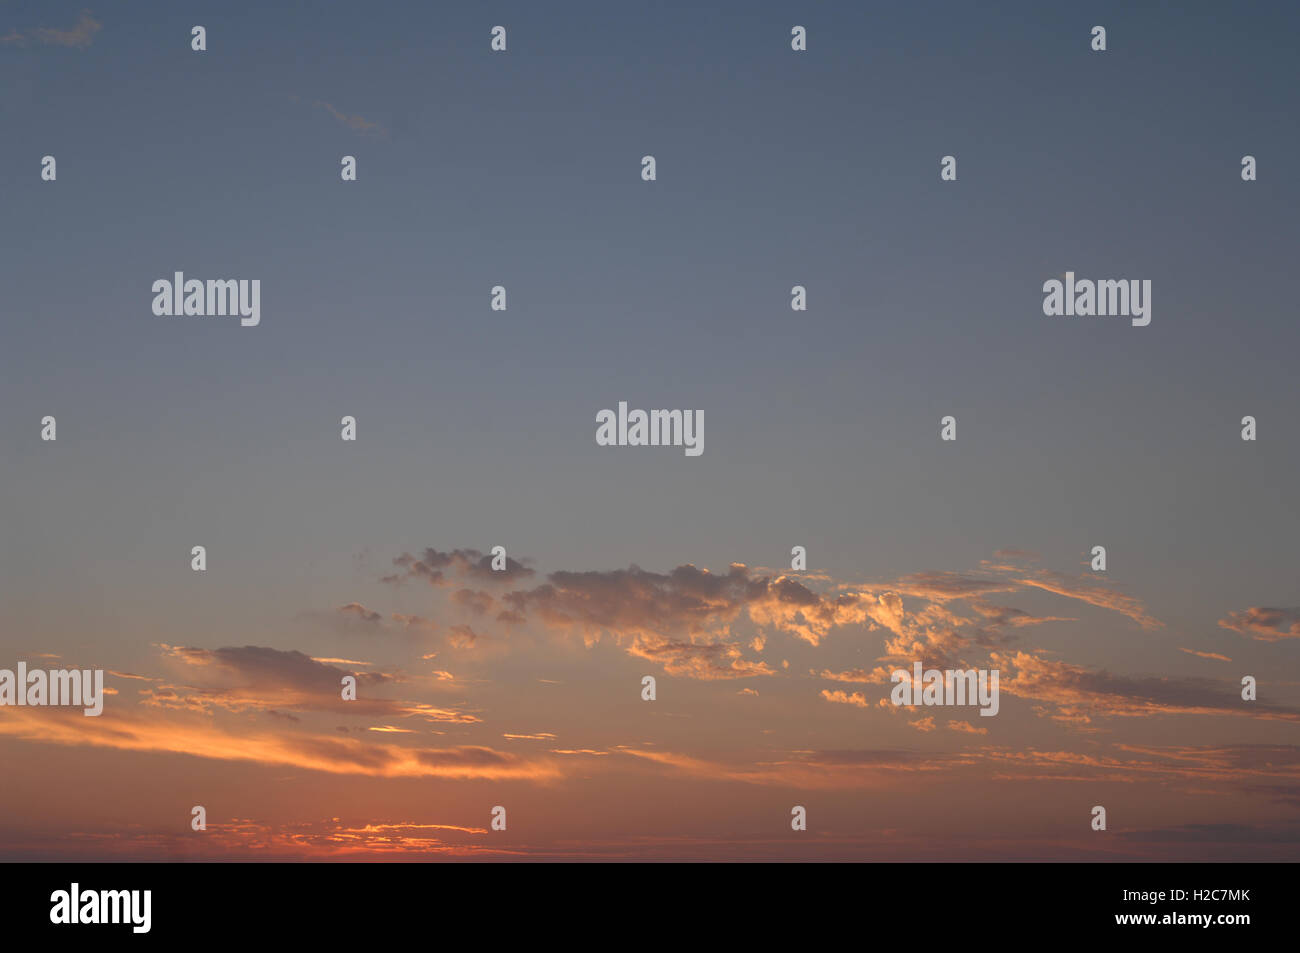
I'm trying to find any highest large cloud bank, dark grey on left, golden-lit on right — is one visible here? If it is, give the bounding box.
[341,547,1161,683]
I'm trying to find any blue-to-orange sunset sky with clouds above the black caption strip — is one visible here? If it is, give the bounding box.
[0,3,1300,861]
